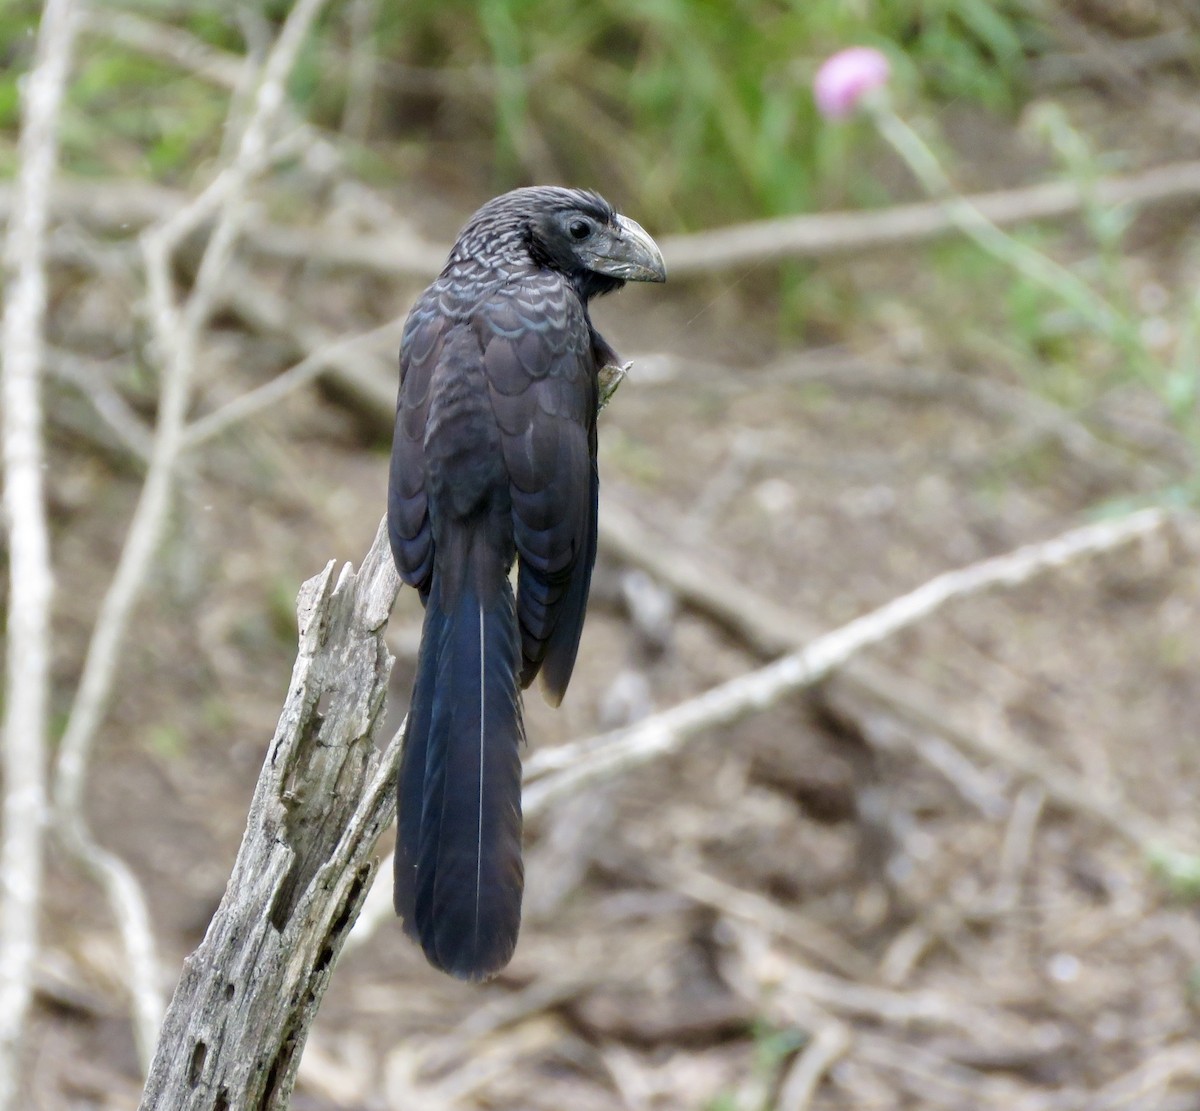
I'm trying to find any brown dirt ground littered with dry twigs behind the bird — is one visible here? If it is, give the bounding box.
[14,56,1200,1111]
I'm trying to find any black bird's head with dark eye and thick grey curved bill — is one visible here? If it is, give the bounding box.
[460,186,667,301]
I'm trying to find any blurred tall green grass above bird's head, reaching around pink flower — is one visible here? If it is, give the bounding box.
[364,0,1039,226]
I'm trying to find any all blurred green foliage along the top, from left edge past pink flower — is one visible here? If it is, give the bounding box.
[0,0,1040,219]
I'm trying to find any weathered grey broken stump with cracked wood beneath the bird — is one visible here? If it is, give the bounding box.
[140,524,400,1111]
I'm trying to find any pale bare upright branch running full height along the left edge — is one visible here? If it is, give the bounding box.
[0,0,78,1109]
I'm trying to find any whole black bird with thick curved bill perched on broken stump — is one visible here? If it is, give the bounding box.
[388,187,666,980]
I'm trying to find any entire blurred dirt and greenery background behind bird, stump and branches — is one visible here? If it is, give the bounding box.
[0,0,1200,1111]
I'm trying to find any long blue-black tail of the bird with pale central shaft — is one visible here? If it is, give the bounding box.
[395,551,524,980]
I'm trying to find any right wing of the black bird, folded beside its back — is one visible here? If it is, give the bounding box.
[476,272,599,704]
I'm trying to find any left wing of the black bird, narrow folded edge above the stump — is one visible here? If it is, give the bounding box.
[388,284,450,597]
